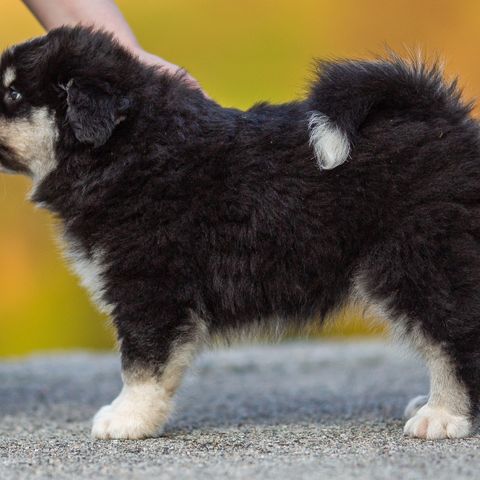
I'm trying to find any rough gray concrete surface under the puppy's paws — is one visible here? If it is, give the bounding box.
[0,341,480,480]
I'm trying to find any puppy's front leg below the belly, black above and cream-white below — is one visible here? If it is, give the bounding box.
[92,321,204,439]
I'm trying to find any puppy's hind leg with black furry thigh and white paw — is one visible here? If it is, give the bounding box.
[355,213,480,439]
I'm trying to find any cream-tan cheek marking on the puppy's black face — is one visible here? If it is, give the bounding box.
[0,107,58,183]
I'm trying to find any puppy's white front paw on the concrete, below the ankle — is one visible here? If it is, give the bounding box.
[92,402,166,440]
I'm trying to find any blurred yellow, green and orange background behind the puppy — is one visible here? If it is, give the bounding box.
[0,0,480,355]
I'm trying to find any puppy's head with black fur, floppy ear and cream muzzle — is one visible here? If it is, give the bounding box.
[0,27,137,180]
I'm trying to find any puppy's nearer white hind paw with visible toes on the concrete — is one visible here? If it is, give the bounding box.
[403,404,472,440]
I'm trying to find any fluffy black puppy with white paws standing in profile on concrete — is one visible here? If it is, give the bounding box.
[0,28,480,439]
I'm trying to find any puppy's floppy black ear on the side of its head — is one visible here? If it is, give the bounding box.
[64,79,130,147]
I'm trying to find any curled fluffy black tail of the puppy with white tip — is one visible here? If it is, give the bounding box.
[309,55,472,169]
